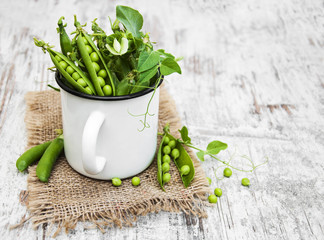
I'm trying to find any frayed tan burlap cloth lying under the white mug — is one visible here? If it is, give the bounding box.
[22,88,210,236]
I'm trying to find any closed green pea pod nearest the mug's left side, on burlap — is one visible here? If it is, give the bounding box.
[36,135,64,182]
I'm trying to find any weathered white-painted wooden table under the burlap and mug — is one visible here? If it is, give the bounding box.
[0,0,324,240]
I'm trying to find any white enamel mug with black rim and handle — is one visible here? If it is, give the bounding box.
[56,74,159,180]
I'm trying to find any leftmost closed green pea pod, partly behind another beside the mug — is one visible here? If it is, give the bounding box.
[16,141,52,172]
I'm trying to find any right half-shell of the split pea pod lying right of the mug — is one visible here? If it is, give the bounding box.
[166,134,195,188]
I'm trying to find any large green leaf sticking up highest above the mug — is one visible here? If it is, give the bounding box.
[116,5,143,38]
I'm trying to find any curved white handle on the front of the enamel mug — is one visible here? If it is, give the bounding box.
[82,111,107,175]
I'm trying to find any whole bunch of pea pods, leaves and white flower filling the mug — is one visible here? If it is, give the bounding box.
[34,6,170,96]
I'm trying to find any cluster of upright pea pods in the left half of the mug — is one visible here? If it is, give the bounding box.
[34,17,115,96]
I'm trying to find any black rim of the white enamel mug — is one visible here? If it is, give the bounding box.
[55,71,164,101]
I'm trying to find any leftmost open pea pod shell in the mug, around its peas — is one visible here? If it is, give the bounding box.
[46,48,96,94]
